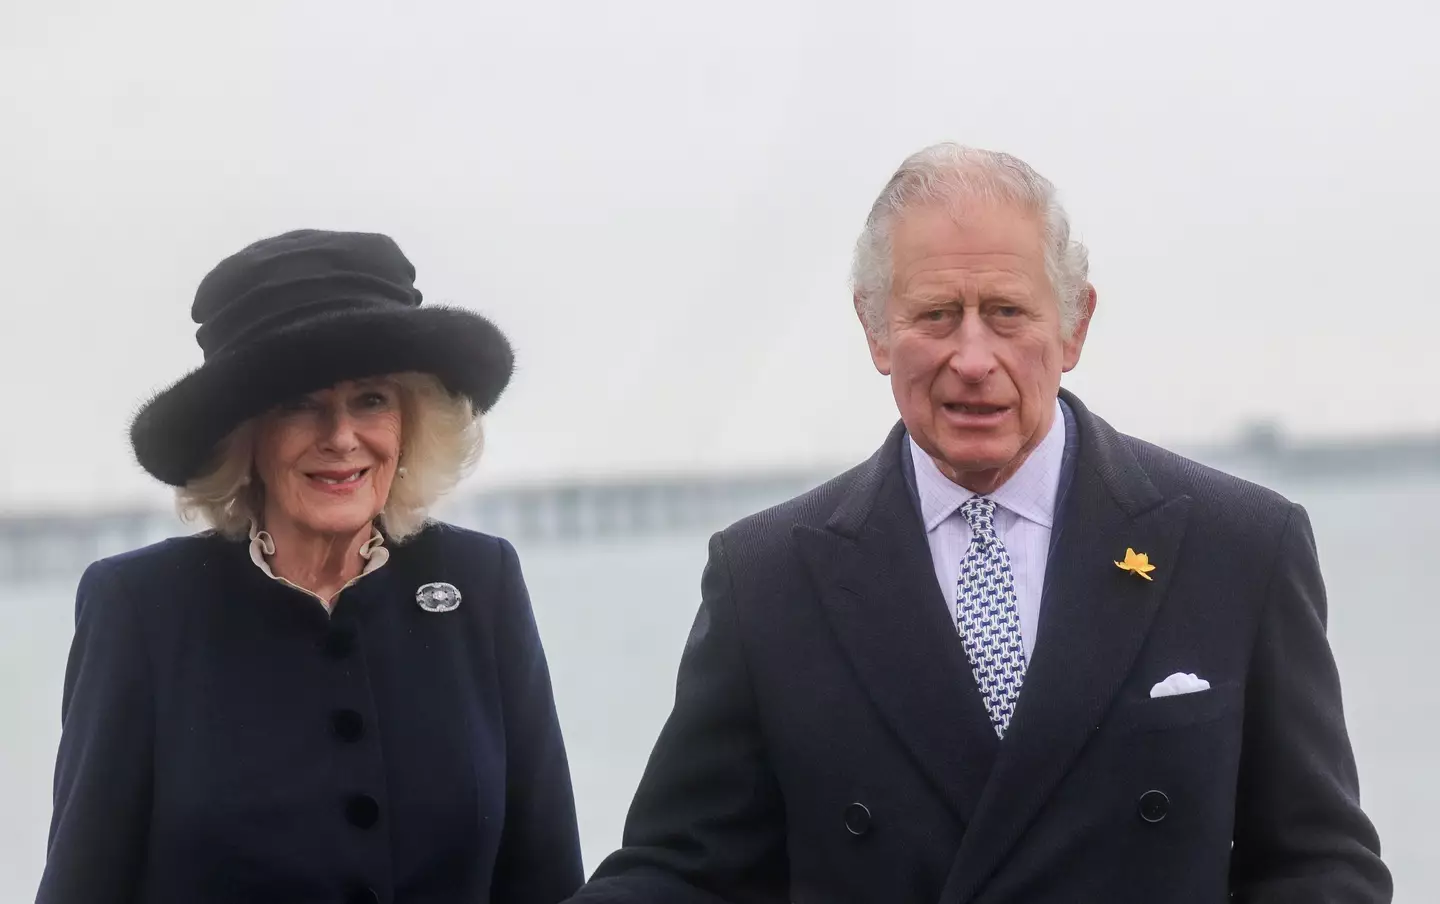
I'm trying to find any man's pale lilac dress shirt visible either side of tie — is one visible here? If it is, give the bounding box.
[910,400,1066,661]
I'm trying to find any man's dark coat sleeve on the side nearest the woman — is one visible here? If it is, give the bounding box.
[576,534,789,904]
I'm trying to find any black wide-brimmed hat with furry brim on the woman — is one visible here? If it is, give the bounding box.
[130,229,514,487]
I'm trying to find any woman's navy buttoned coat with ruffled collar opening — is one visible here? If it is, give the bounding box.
[37,524,583,904]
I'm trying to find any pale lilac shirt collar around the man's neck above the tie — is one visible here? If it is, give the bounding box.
[909,399,1066,533]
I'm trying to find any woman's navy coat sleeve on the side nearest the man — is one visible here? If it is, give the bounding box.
[490,540,585,904]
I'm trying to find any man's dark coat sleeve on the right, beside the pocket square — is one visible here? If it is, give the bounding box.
[1231,505,1391,904]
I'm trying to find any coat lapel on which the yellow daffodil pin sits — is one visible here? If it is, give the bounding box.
[942,393,1189,901]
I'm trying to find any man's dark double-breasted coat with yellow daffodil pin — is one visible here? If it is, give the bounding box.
[575,393,1391,904]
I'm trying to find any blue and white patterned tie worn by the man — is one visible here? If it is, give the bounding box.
[956,497,1025,737]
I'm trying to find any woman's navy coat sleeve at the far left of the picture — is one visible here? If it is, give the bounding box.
[36,563,154,904]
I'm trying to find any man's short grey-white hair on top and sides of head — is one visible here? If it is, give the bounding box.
[850,143,1090,337]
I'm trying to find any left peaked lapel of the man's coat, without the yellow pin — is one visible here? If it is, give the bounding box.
[795,428,998,821]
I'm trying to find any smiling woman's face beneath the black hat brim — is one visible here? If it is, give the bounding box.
[255,379,400,535]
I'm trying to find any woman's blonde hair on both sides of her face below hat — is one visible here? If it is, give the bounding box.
[176,373,484,543]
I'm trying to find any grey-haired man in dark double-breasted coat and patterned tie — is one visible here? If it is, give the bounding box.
[576,145,1391,904]
